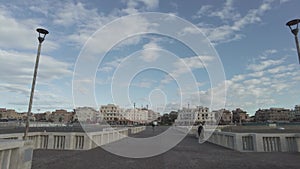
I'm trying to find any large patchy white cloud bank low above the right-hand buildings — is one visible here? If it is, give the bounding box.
[172,50,300,114]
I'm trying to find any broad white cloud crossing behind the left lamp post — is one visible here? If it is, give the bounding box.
[0,50,72,90]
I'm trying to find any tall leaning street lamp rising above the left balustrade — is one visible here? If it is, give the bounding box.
[23,28,49,140]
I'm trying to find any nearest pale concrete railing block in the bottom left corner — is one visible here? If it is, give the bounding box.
[0,139,33,169]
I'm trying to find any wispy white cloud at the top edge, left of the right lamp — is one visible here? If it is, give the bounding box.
[193,0,273,43]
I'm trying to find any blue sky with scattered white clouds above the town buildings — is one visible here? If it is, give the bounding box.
[0,0,300,114]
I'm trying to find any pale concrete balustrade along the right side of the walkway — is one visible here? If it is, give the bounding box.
[204,131,300,152]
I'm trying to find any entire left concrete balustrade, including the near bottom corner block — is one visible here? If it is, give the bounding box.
[0,126,145,169]
